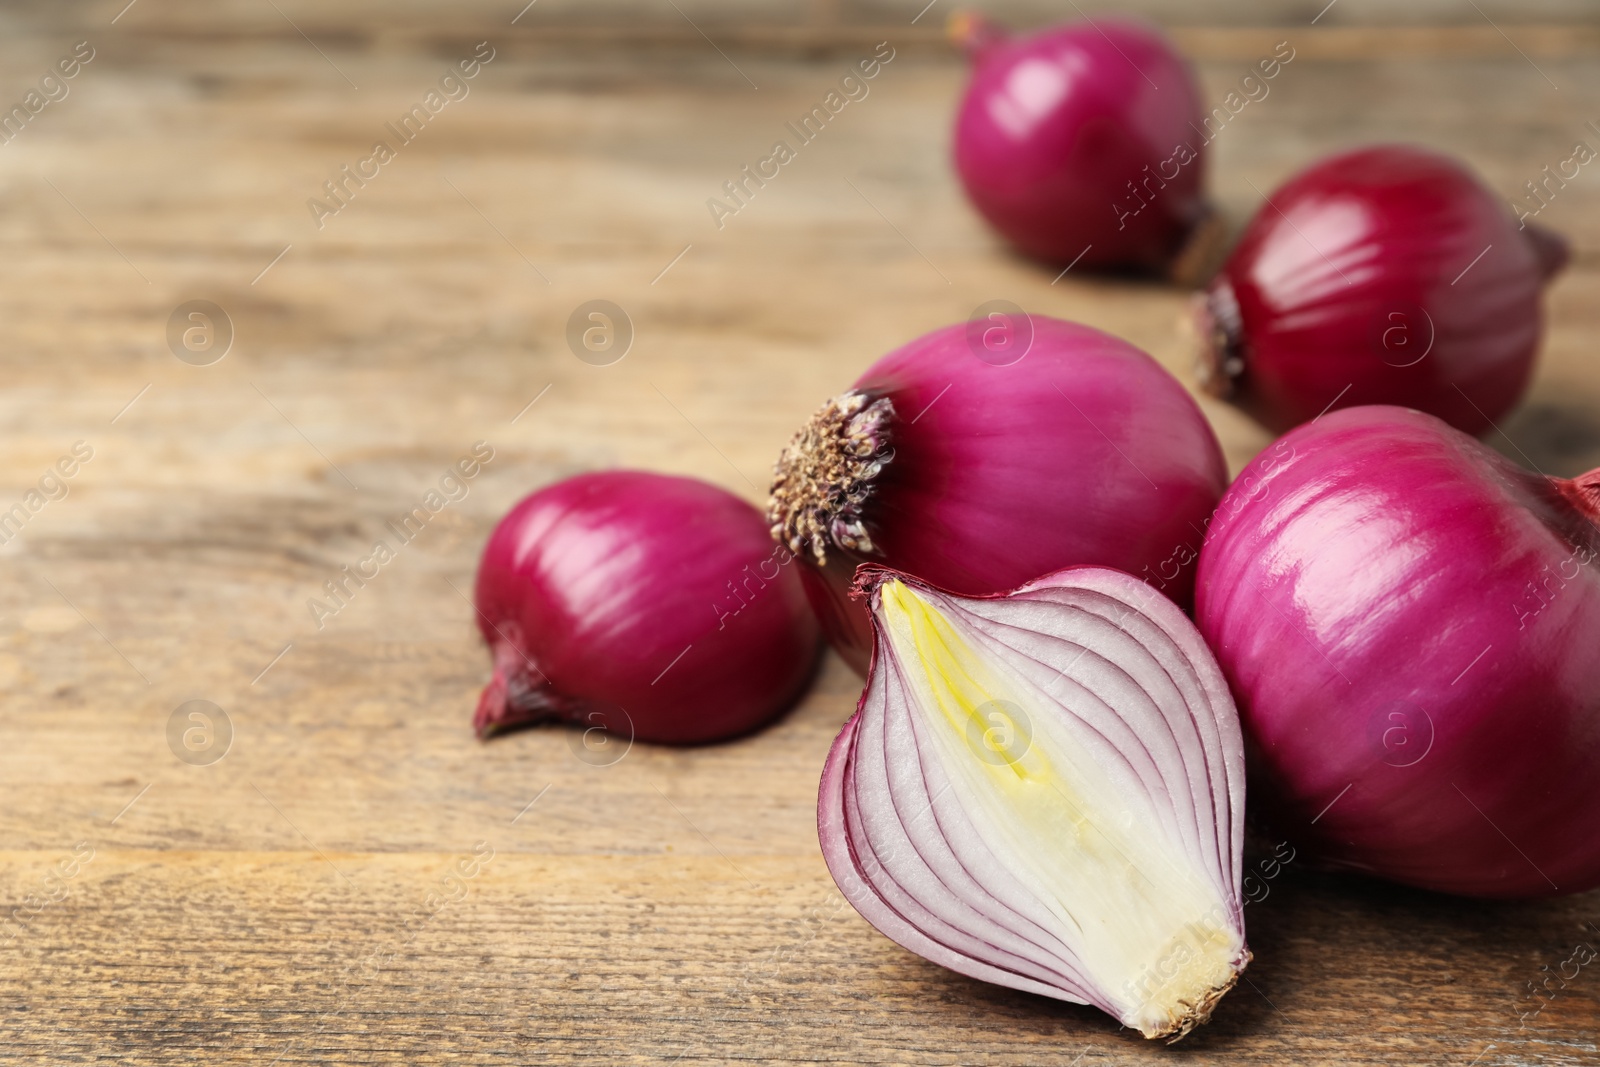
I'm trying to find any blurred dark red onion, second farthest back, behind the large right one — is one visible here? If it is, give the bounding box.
[1195,146,1566,434]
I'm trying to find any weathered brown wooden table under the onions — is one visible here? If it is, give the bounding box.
[0,0,1600,1067]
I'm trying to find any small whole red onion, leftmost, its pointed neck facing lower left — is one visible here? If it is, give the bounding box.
[474,470,819,744]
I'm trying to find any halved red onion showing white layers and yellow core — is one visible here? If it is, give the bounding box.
[818,566,1250,1040]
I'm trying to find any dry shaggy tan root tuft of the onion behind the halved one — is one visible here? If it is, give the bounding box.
[766,389,894,566]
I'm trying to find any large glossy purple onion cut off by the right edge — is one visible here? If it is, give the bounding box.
[1195,406,1600,897]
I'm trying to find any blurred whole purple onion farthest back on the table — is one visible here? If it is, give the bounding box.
[954,16,1208,270]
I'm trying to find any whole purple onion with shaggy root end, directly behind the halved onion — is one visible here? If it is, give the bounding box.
[768,314,1227,673]
